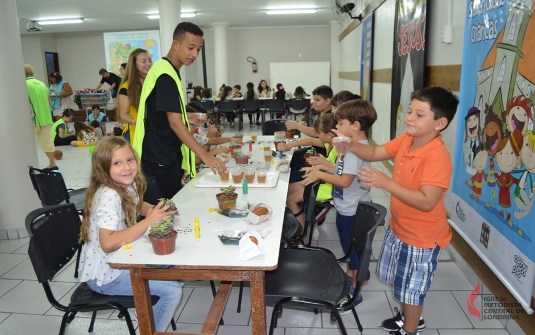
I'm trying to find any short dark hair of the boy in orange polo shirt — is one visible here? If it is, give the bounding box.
[411,86,459,131]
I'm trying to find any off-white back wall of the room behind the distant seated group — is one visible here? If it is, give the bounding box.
[22,26,331,100]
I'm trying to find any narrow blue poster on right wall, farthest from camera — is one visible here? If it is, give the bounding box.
[360,12,373,101]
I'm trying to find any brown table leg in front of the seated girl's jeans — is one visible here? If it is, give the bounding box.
[130,268,156,335]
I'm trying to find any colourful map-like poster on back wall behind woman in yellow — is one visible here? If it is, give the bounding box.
[104,30,161,73]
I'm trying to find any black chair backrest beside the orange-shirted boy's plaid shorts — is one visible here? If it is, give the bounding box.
[351,201,386,282]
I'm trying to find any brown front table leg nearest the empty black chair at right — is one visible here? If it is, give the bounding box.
[251,271,266,335]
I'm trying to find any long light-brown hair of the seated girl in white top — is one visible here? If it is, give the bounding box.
[80,136,147,243]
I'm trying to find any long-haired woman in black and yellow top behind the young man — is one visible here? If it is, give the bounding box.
[119,48,152,144]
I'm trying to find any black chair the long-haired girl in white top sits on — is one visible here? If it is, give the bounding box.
[26,203,176,335]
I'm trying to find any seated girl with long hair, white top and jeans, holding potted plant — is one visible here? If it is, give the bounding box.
[78,136,183,332]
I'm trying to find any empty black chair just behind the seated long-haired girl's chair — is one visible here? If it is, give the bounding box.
[29,166,87,212]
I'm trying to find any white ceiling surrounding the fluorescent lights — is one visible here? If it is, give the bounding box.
[17,0,352,34]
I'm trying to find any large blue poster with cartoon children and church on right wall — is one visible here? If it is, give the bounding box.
[451,0,535,308]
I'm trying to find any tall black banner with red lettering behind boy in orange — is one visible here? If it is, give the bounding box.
[390,0,429,138]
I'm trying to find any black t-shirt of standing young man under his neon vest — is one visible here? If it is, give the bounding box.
[143,58,182,166]
